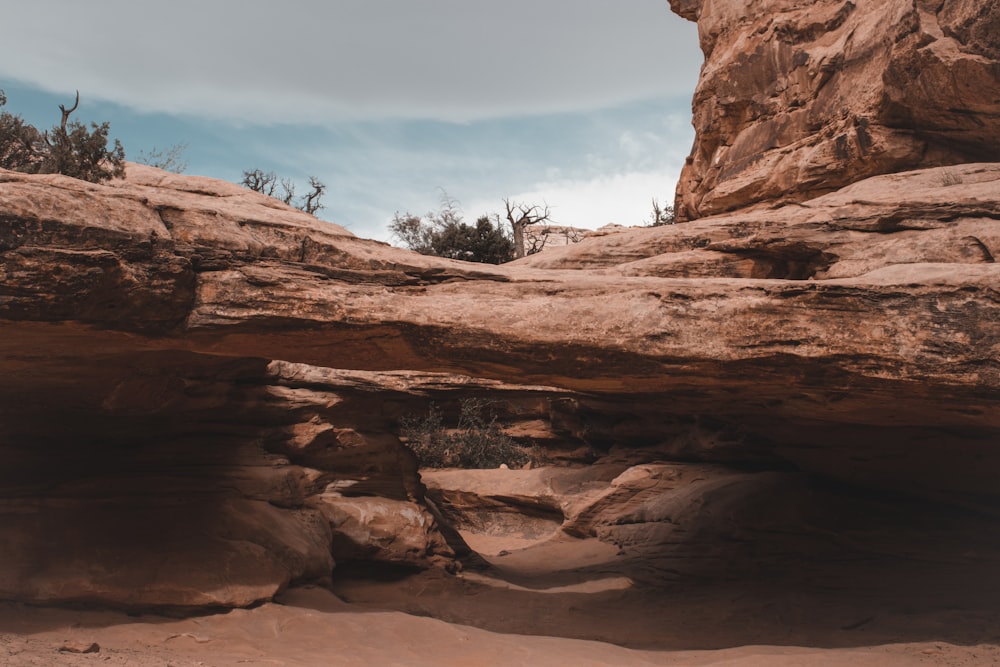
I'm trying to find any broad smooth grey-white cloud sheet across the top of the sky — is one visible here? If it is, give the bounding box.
[0,0,701,124]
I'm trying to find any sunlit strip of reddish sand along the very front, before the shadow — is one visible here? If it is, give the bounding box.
[0,589,1000,667]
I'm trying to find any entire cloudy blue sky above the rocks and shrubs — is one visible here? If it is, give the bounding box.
[0,0,702,241]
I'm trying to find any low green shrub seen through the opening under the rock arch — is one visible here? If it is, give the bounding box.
[400,398,533,468]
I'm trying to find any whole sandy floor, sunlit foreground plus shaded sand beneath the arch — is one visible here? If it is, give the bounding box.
[0,537,1000,667]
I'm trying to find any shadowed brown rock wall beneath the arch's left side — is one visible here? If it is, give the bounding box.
[0,321,453,608]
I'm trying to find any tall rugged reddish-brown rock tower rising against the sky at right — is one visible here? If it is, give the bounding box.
[670,0,1000,220]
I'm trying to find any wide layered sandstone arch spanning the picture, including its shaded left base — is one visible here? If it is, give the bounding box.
[0,159,1000,606]
